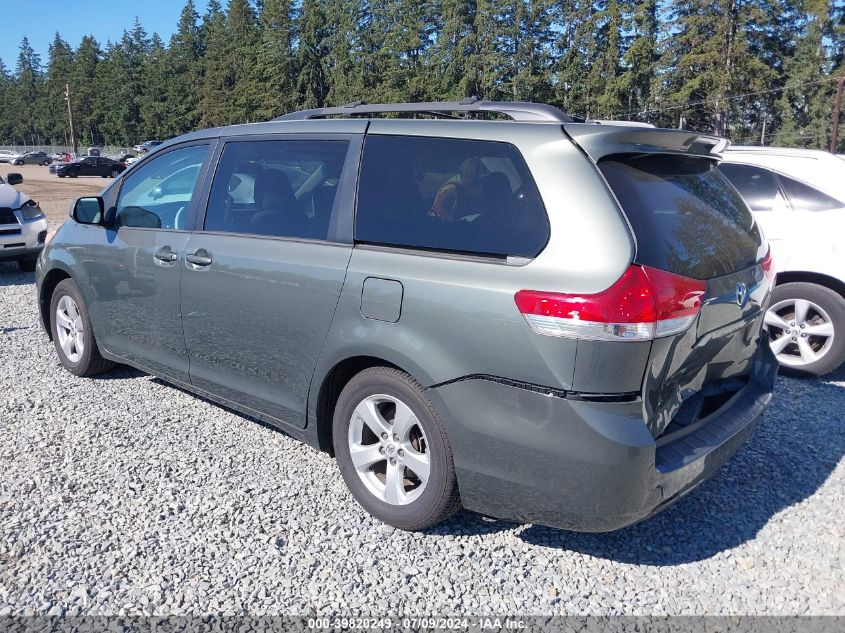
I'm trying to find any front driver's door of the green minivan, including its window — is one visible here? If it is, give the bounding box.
[89,144,209,383]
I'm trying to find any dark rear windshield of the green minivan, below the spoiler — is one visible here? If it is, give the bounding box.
[599,154,763,279]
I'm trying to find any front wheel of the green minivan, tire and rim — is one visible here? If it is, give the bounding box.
[50,279,114,376]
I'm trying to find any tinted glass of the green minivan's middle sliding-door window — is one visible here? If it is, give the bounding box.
[205,140,348,240]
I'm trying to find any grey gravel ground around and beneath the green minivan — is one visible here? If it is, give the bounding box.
[0,254,845,615]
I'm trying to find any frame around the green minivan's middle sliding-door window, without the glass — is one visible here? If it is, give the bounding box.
[194,132,364,246]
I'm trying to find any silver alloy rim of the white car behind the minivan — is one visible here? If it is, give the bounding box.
[765,299,834,367]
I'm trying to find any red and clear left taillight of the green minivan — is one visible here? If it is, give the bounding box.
[515,265,707,341]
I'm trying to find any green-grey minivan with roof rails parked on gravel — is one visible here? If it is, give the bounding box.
[37,101,777,531]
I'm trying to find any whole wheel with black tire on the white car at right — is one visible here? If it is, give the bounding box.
[766,282,845,376]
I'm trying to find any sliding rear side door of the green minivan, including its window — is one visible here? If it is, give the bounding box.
[182,135,360,427]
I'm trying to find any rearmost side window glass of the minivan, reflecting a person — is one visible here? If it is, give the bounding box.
[355,135,549,257]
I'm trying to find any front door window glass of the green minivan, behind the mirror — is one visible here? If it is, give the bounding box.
[115,145,208,230]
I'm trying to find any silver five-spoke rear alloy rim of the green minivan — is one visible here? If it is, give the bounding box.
[348,394,431,505]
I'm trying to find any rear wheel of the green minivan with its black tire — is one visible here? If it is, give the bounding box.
[332,367,460,530]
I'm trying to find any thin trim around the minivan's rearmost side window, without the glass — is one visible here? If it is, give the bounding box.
[352,132,552,263]
